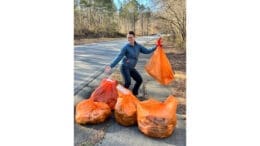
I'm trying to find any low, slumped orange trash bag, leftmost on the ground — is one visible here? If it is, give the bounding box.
[75,99,111,124]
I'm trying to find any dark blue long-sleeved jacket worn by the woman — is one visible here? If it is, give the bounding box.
[110,42,156,68]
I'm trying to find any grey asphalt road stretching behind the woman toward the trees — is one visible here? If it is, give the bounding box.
[74,36,158,93]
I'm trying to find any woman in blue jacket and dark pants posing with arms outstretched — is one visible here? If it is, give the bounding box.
[105,31,160,96]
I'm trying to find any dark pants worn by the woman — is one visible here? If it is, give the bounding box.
[120,65,143,95]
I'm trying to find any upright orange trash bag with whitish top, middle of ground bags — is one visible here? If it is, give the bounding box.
[115,84,139,126]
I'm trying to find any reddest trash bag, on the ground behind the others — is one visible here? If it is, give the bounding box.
[90,78,118,110]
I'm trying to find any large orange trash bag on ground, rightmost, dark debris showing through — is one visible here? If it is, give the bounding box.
[137,96,177,138]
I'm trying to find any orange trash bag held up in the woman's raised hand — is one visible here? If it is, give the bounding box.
[145,39,174,85]
